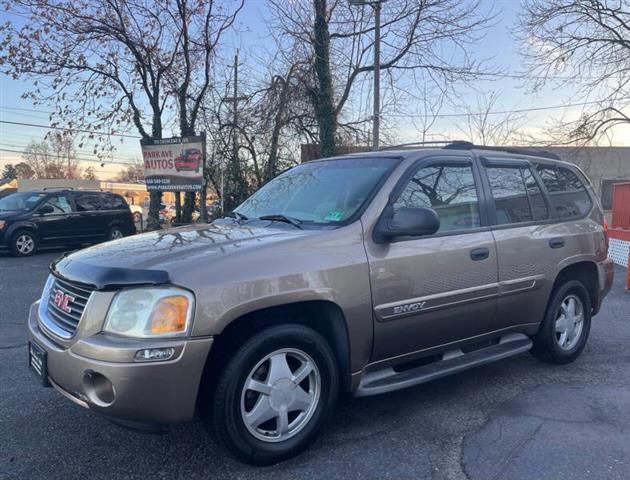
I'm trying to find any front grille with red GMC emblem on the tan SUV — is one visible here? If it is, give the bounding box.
[48,277,94,336]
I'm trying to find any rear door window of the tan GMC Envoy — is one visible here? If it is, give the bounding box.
[486,167,549,225]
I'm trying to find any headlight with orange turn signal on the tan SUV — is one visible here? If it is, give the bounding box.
[103,287,195,338]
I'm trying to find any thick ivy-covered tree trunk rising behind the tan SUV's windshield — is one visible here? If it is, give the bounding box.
[313,0,337,157]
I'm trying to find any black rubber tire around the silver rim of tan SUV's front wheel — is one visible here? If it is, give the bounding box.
[209,324,339,465]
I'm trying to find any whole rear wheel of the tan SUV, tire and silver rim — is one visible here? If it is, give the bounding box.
[532,280,591,364]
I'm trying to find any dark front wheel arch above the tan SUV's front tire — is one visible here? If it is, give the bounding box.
[197,300,351,412]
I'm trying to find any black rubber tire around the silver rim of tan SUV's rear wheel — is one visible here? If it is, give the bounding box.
[531,280,591,365]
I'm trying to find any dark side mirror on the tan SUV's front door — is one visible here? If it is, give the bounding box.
[375,207,440,242]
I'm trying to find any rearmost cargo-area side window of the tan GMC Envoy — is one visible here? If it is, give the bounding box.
[537,165,593,220]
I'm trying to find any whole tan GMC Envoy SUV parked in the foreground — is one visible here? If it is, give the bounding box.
[28,142,613,464]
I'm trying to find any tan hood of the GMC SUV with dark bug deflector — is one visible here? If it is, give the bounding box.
[51,223,313,289]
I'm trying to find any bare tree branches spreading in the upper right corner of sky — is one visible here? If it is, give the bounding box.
[518,0,630,143]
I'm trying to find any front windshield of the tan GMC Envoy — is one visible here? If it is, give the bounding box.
[235,157,398,224]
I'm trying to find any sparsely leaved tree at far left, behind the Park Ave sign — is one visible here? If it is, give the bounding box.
[0,0,186,228]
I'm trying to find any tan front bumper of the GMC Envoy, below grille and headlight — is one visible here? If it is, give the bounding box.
[28,302,213,424]
